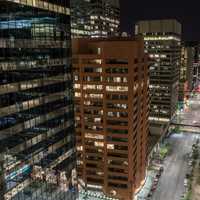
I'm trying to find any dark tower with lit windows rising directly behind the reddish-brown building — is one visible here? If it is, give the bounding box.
[71,0,120,38]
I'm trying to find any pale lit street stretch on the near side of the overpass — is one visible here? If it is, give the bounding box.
[152,133,199,200]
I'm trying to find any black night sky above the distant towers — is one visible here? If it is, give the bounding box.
[121,0,200,41]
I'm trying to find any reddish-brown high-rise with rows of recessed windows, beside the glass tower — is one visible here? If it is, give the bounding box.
[73,37,149,200]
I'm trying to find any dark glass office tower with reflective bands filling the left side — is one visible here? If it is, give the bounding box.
[0,0,76,200]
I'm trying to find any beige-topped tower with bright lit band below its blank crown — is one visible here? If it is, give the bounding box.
[135,20,181,134]
